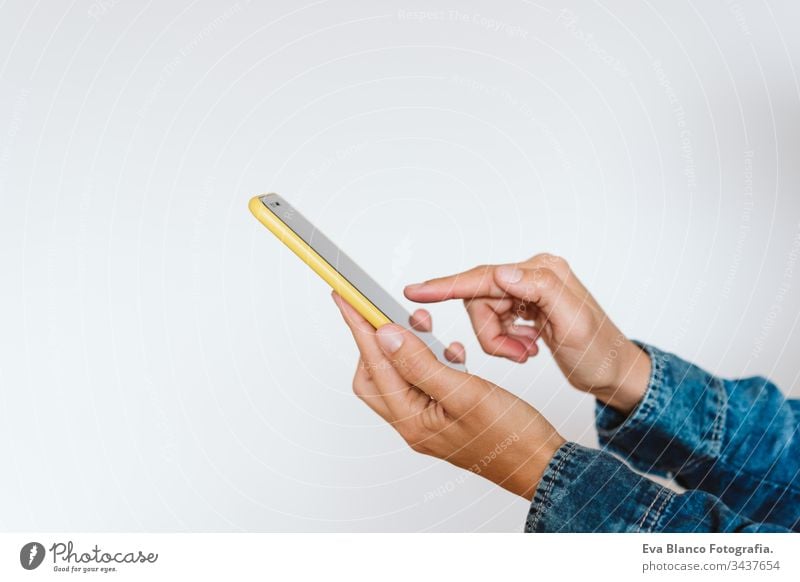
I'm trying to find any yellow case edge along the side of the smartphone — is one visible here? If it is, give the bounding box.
[248,196,392,329]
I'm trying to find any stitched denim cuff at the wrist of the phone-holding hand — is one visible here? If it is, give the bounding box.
[525,442,675,532]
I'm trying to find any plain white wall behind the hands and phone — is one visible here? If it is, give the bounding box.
[0,0,800,531]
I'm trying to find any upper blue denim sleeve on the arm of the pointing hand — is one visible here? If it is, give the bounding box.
[596,344,800,529]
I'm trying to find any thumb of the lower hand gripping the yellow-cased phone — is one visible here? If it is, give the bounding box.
[376,323,483,414]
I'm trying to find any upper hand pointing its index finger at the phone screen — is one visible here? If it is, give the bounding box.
[405,254,650,413]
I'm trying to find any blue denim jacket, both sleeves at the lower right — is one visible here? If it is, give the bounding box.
[525,344,800,532]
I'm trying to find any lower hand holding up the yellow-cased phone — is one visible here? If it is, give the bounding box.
[333,293,564,499]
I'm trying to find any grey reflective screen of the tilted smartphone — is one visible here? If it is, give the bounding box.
[259,194,465,370]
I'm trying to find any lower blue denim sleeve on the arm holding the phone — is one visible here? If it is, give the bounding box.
[525,442,790,532]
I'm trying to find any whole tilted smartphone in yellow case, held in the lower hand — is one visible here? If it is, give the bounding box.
[249,194,465,370]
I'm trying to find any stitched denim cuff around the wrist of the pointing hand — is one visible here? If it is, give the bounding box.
[595,342,726,477]
